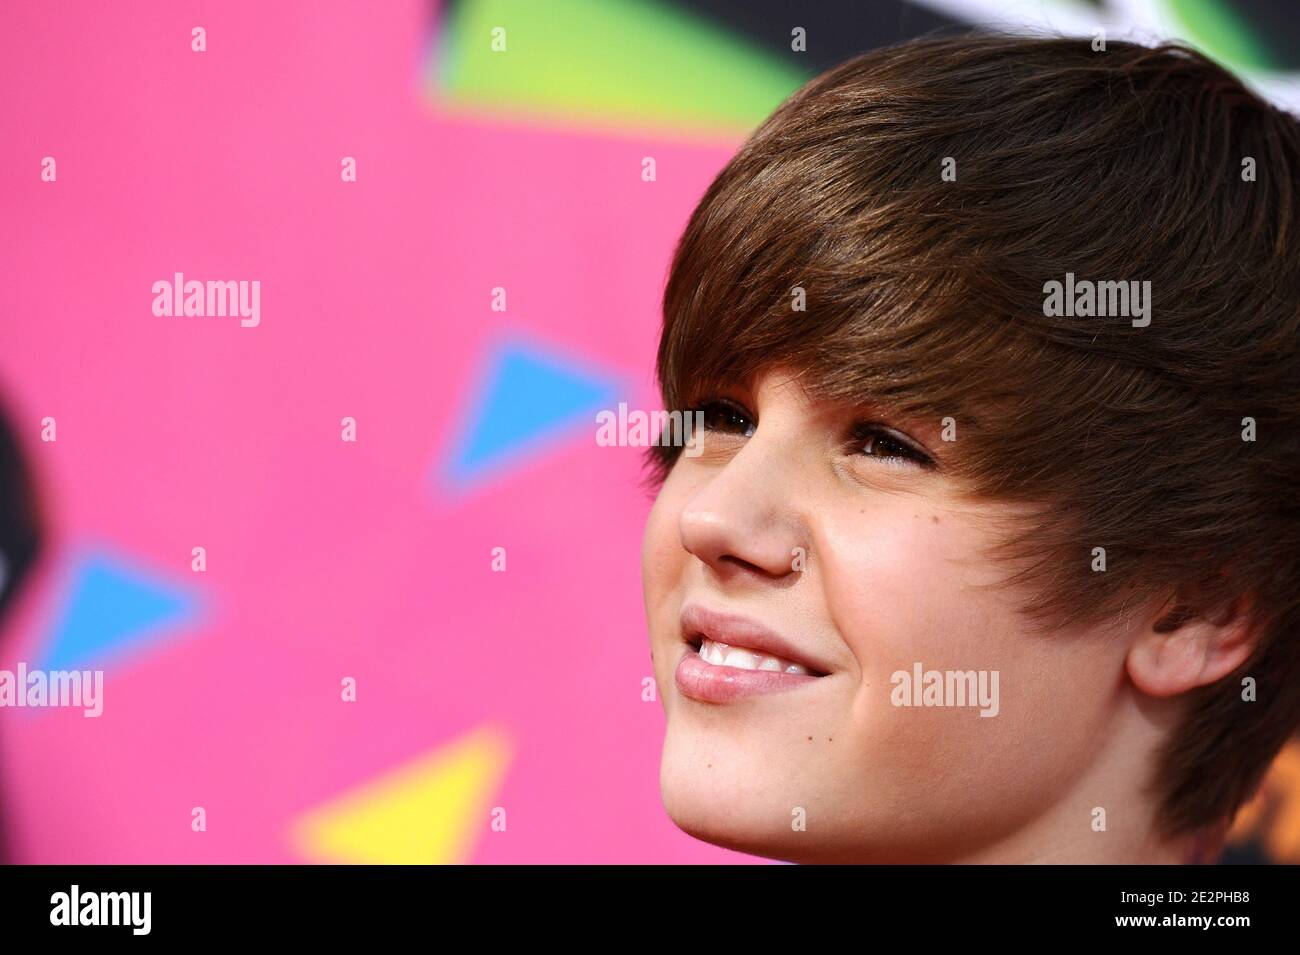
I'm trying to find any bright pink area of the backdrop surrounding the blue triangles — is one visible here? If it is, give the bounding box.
[0,0,759,863]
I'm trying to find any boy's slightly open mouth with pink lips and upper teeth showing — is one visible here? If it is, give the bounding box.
[676,604,829,703]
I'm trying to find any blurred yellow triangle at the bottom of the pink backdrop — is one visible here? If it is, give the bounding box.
[293,728,510,865]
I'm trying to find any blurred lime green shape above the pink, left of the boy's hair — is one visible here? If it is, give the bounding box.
[436,0,805,131]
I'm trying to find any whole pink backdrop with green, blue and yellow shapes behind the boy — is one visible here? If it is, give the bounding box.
[0,0,1300,863]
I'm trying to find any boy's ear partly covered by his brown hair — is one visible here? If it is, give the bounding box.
[1125,587,1255,696]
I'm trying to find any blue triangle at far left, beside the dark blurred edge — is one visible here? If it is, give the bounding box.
[40,552,196,670]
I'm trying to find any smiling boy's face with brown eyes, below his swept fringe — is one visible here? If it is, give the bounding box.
[642,372,1156,861]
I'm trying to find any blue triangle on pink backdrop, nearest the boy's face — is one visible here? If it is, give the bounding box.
[451,342,619,483]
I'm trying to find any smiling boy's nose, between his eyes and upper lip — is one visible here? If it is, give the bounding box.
[677,433,807,579]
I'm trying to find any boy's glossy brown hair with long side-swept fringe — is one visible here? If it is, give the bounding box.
[651,35,1300,835]
